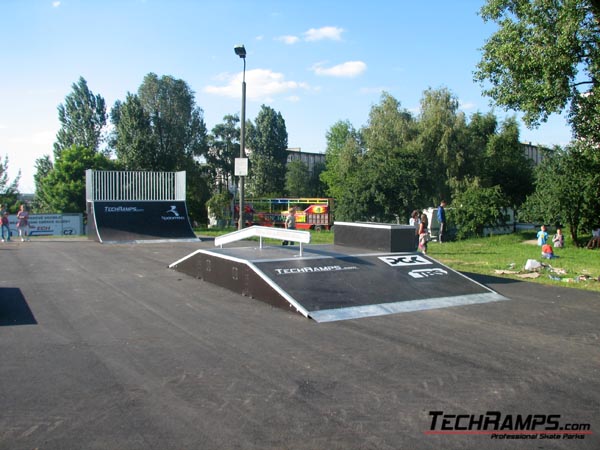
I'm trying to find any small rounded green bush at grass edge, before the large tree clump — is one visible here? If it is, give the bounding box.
[447,179,508,239]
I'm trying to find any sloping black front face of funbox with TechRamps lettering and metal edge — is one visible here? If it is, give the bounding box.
[253,253,506,322]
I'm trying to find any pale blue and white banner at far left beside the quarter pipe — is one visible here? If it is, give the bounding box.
[8,214,84,236]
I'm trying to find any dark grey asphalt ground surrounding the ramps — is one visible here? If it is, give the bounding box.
[0,239,600,450]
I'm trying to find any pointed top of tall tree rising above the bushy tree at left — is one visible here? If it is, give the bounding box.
[54,77,106,156]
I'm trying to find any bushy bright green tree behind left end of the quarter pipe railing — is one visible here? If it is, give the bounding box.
[36,145,115,213]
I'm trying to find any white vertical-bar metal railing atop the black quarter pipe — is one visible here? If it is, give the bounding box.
[85,169,185,202]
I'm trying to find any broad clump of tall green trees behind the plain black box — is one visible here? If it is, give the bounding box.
[321,89,531,227]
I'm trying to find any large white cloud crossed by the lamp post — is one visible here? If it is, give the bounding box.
[204,69,309,102]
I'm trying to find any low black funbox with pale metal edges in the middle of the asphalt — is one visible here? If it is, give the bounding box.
[169,223,507,322]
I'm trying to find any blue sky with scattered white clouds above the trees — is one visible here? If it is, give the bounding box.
[0,0,571,192]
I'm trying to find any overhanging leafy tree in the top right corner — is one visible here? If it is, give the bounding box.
[474,0,600,143]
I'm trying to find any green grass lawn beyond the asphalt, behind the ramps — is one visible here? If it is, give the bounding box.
[196,228,600,292]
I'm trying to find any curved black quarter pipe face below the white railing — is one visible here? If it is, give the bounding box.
[88,201,198,244]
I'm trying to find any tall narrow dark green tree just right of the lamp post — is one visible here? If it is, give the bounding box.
[247,105,288,197]
